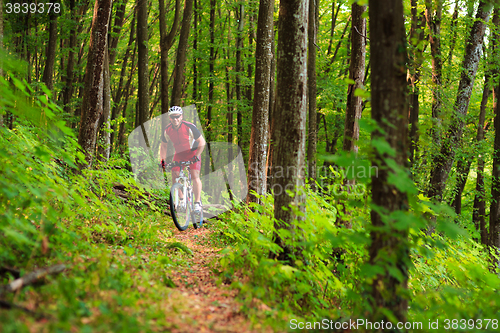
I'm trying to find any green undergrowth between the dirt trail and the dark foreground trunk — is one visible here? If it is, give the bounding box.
[215,189,360,316]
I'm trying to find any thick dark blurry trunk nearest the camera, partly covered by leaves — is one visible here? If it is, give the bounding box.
[369,0,411,322]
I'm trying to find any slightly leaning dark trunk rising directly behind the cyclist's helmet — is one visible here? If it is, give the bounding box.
[170,0,193,106]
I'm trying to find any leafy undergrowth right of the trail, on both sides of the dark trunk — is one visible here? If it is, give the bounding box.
[213,188,500,332]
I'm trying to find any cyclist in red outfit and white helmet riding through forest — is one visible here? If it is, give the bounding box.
[160,106,206,212]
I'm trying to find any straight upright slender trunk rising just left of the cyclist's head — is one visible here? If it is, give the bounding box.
[135,0,149,127]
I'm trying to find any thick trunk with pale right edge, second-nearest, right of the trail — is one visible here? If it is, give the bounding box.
[273,0,309,265]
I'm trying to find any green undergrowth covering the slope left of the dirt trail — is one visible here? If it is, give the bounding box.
[0,54,194,332]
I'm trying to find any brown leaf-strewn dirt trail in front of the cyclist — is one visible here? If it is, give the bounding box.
[166,228,272,333]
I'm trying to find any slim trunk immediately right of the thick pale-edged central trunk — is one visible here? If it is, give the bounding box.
[307,0,319,190]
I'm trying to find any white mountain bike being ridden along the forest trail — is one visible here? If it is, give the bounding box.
[165,161,203,231]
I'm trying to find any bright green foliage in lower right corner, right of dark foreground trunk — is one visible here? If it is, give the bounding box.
[409,235,500,322]
